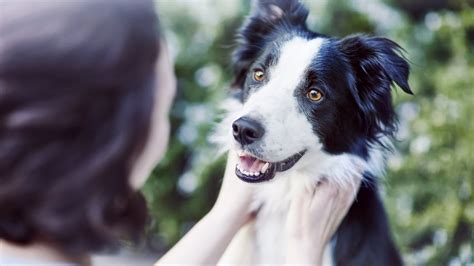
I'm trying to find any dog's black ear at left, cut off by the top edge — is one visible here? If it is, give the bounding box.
[232,0,309,89]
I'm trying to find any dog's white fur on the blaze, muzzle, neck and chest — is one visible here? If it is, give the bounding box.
[214,37,385,265]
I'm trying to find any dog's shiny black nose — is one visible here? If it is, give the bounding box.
[232,116,265,145]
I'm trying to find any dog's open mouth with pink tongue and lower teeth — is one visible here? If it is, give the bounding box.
[235,150,306,183]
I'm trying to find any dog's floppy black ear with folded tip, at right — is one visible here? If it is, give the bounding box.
[338,35,413,137]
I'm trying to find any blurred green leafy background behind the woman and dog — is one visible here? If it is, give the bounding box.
[138,0,474,265]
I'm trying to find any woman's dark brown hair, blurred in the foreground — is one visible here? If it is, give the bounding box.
[0,0,159,254]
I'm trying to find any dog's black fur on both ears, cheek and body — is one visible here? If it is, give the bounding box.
[233,0,412,266]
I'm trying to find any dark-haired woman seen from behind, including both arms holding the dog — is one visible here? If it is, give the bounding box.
[0,0,360,265]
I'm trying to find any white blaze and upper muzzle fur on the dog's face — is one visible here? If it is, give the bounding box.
[236,37,324,159]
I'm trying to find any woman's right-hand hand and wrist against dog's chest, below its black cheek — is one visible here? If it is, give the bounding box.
[286,177,361,265]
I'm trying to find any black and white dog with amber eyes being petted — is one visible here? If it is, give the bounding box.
[215,0,412,265]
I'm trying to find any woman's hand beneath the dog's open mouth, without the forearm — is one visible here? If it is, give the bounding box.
[211,150,255,228]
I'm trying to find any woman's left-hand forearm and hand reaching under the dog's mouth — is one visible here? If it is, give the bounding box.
[155,153,252,265]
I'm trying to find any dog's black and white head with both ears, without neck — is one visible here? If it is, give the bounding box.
[227,0,411,182]
